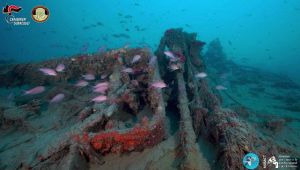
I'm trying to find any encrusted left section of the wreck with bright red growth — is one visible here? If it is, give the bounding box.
[0,48,166,169]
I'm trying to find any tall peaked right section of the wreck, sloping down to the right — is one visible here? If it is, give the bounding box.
[155,29,298,170]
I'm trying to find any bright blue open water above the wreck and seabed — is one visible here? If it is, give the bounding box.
[0,0,300,82]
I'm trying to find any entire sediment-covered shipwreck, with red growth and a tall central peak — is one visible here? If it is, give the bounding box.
[0,29,300,170]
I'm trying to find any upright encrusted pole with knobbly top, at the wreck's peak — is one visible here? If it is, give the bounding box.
[156,29,210,169]
